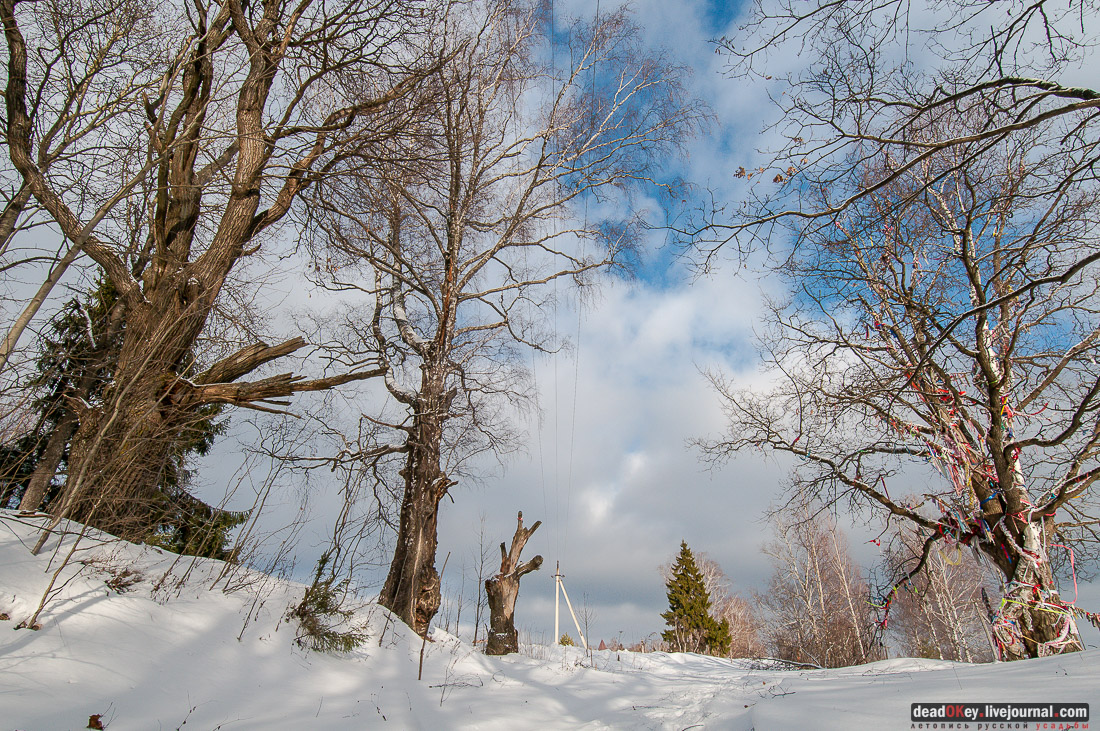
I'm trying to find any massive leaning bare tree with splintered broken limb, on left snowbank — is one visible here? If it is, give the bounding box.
[0,0,451,547]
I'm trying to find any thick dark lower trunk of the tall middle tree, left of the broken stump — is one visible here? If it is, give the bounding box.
[378,367,455,635]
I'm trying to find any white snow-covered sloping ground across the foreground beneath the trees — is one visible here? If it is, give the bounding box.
[0,512,1100,731]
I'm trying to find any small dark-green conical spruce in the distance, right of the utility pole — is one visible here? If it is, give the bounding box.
[661,541,732,655]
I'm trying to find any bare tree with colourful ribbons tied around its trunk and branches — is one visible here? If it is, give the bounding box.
[706,122,1100,658]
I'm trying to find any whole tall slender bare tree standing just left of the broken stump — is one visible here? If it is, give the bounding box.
[314,1,702,633]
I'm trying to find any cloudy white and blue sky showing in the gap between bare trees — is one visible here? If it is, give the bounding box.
[180,0,1100,642]
